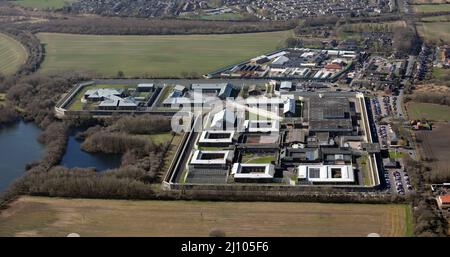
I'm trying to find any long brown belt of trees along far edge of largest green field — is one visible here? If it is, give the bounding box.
[4,16,297,35]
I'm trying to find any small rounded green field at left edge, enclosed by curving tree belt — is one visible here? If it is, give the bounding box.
[0,34,27,75]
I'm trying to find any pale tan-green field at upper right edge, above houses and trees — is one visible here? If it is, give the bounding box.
[417,21,450,43]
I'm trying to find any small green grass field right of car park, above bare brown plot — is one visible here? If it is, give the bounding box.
[407,102,450,121]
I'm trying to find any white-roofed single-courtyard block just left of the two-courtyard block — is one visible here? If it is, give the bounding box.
[231,163,275,182]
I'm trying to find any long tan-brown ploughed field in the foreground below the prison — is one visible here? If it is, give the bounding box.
[0,197,411,237]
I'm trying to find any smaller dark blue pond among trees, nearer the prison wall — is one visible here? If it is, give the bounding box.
[61,130,121,171]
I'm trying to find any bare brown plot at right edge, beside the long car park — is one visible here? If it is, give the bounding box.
[416,123,450,177]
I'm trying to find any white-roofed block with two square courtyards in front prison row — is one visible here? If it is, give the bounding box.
[297,164,355,184]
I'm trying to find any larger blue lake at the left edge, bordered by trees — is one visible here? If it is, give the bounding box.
[0,121,44,191]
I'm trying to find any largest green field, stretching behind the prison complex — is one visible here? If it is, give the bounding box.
[38,31,291,77]
